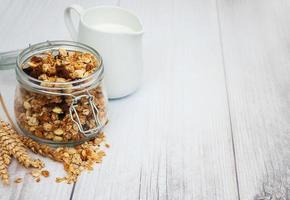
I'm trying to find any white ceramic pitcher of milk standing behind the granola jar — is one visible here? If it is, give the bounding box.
[64,5,143,99]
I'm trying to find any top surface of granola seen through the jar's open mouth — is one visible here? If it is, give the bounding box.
[22,49,100,82]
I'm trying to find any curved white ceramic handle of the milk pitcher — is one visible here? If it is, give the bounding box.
[64,5,84,41]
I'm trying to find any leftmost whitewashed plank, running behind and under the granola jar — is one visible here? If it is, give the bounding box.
[0,0,116,200]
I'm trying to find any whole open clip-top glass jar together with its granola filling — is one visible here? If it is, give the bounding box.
[14,41,107,145]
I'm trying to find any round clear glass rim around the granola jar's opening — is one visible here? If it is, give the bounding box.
[15,40,104,90]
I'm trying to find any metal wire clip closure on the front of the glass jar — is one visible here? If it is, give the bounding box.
[69,91,103,137]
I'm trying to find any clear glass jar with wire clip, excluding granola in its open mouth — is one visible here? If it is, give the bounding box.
[14,41,107,146]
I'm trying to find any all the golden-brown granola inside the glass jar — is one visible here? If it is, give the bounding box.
[14,49,107,142]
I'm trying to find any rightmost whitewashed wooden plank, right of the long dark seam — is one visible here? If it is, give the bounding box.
[218,0,290,199]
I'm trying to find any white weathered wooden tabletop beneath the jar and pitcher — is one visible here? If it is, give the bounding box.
[0,0,290,200]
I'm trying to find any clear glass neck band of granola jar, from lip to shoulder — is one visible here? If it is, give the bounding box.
[16,41,104,95]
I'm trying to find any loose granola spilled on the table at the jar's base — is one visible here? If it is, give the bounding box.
[20,130,109,184]
